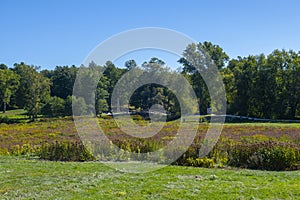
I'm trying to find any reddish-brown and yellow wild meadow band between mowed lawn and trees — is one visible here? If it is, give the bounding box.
[0,117,300,170]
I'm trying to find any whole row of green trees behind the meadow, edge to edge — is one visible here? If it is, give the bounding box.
[0,42,300,120]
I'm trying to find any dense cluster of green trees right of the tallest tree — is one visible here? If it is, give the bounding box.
[223,50,300,119]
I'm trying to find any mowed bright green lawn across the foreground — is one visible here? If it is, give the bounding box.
[0,156,300,199]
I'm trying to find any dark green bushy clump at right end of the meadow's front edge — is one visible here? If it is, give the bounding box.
[228,141,300,171]
